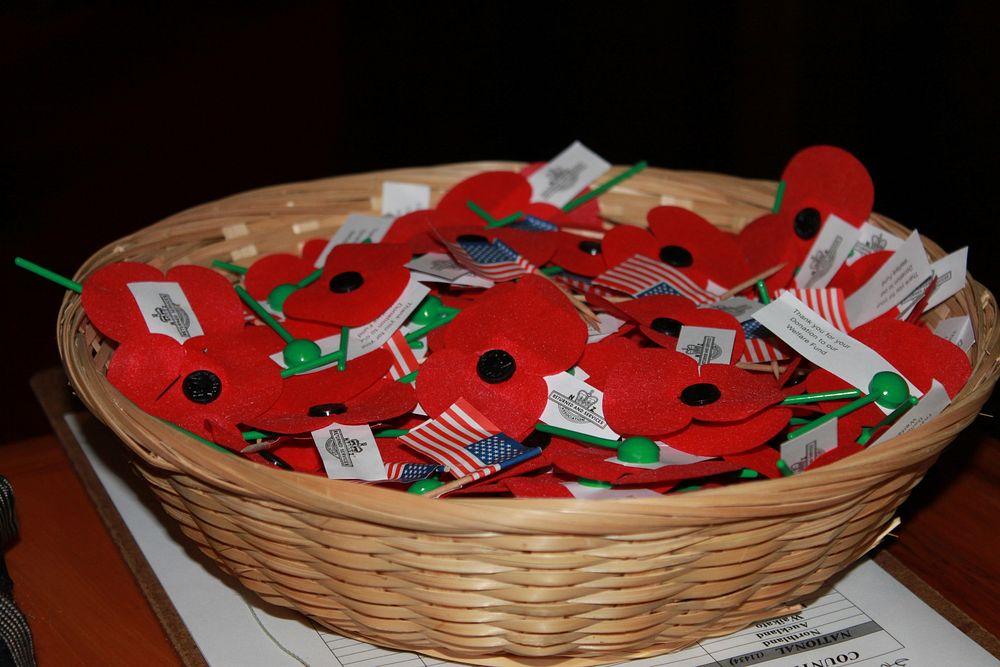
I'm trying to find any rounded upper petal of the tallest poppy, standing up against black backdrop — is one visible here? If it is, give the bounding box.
[781,146,875,227]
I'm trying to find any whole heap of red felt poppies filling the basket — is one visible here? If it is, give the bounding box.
[76,147,970,497]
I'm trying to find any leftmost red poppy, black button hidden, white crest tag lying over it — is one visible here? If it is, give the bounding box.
[82,262,245,342]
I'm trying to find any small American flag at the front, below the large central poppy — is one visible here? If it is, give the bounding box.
[399,398,541,479]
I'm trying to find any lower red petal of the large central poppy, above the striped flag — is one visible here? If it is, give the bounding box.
[417,348,548,440]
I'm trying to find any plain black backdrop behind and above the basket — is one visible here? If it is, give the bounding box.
[0,2,1000,440]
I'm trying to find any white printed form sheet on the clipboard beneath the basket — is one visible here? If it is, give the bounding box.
[66,413,1000,667]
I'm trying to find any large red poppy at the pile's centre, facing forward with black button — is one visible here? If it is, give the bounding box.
[417,276,587,440]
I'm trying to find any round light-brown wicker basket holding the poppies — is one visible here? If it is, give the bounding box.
[58,162,1000,665]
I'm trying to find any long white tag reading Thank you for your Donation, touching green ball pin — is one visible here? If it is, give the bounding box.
[754,293,921,412]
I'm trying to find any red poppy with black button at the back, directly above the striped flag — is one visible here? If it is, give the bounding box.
[601,206,750,287]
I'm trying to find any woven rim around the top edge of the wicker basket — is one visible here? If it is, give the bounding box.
[59,161,1000,533]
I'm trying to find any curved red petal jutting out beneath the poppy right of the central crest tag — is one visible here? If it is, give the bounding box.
[658,408,792,456]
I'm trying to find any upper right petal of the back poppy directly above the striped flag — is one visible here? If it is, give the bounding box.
[646,206,750,287]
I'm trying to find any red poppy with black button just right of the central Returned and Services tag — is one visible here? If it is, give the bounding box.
[604,349,784,436]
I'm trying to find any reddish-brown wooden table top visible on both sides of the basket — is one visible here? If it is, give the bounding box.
[0,370,1000,667]
